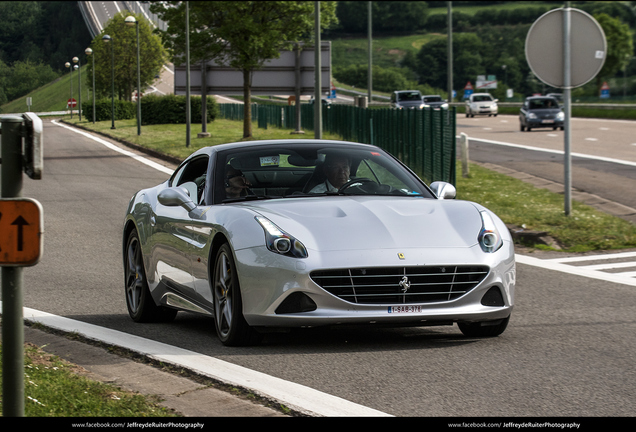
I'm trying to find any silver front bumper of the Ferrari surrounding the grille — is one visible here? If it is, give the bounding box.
[236,242,515,327]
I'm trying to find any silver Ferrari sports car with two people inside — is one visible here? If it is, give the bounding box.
[123,140,515,345]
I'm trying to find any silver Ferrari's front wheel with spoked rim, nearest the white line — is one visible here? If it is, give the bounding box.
[212,243,260,346]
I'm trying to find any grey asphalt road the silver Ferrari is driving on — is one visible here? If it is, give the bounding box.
[4,117,636,417]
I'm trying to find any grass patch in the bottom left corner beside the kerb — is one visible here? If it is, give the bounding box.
[0,345,177,417]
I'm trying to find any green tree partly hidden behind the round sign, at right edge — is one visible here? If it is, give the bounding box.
[594,13,634,94]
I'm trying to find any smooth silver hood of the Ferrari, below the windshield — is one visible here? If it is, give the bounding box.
[245,196,482,251]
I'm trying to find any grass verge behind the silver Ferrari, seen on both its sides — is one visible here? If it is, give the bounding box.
[65,117,636,252]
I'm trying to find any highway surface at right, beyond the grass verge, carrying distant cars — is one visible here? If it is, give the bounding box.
[457,115,636,208]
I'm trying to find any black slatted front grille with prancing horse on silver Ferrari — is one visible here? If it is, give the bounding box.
[310,265,489,304]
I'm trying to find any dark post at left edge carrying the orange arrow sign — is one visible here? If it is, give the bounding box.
[0,113,43,417]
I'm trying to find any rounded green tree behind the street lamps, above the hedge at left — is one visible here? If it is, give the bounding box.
[88,12,166,101]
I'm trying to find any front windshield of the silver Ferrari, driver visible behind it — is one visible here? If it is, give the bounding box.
[213,142,434,204]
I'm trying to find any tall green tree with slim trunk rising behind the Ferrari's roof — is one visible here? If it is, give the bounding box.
[153,1,336,138]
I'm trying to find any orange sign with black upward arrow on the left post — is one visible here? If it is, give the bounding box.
[0,198,44,267]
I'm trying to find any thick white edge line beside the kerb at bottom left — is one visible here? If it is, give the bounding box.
[16,302,392,417]
